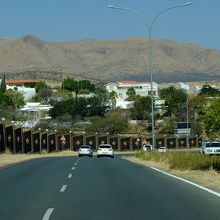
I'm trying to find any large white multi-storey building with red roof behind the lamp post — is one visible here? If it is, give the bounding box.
[106,80,158,109]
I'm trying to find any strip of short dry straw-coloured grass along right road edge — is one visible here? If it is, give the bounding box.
[124,156,220,192]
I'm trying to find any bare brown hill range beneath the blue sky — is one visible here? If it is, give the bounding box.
[0,36,220,83]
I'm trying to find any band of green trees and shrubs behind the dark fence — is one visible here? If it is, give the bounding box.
[0,77,220,140]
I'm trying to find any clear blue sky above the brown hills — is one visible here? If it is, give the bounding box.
[0,0,220,50]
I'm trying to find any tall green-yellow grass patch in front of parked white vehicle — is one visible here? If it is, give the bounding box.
[135,151,220,172]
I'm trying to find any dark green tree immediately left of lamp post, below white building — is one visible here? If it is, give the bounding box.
[130,96,151,120]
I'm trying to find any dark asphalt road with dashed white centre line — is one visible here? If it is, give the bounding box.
[0,156,220,220]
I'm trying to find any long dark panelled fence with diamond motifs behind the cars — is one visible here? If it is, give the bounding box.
[0,123,202,153]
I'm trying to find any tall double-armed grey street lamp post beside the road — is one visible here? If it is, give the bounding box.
[107,2,192,149]
